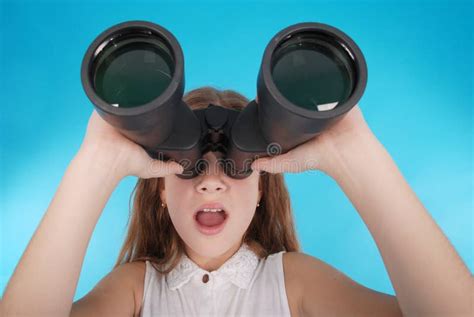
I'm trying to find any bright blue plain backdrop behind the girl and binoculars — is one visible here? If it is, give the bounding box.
[0,1,473,299]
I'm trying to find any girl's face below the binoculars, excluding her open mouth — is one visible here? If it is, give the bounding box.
[161,152,261,258]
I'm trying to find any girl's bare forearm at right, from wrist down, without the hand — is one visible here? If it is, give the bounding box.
[326,122,473,316]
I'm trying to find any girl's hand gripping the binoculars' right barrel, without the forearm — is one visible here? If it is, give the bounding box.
[251,105,372,176]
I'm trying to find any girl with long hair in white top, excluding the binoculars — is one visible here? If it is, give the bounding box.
[2,87,473,317]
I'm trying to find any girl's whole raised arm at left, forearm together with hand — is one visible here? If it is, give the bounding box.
[0,111,181,316]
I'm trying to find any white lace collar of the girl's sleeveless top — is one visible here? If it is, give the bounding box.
[166,243,259,289]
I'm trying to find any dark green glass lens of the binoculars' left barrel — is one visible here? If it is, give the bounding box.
[93,30,175,108]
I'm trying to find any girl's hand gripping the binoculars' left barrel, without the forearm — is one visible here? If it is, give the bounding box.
[80,109,183,179]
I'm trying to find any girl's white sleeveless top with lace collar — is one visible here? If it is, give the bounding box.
[140,243,290,317]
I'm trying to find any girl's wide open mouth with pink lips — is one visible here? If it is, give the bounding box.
[194,204,229,235]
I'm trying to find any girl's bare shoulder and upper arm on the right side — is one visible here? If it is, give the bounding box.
[283,252,401,316]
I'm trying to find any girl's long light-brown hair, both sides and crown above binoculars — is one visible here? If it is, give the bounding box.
[114,86,300,274]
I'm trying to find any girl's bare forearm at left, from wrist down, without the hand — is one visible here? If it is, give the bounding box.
[3,147,122,316]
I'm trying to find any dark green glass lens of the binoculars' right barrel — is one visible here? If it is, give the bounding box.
[271,32,355,111]
